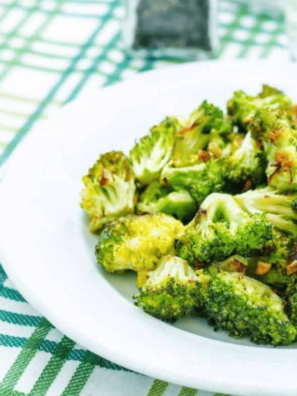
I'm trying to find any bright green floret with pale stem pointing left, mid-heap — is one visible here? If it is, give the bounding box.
[161,158,225,205]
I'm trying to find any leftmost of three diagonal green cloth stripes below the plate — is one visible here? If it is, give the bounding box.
[0,318,52,396]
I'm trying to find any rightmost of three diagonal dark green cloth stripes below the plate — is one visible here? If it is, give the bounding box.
[61,352,99,396]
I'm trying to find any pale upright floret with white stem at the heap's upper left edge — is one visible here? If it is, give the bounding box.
[130,117,181,185]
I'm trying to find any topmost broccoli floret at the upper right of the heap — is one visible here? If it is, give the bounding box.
[227,85,292,131]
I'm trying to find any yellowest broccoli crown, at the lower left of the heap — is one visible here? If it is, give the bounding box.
[95,213,183,273]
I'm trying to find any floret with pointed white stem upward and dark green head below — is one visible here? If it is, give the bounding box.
[226,133,267,190]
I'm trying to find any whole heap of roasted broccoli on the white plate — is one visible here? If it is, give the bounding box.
[81,85,297,346]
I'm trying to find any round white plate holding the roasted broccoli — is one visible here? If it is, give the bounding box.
[0,61,297,396]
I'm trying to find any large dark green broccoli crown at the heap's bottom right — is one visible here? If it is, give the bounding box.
[205,271,297,345]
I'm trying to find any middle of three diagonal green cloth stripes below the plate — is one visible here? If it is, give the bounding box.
[28,336,74,396]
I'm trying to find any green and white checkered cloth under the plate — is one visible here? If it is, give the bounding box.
[0,0,288,396]
